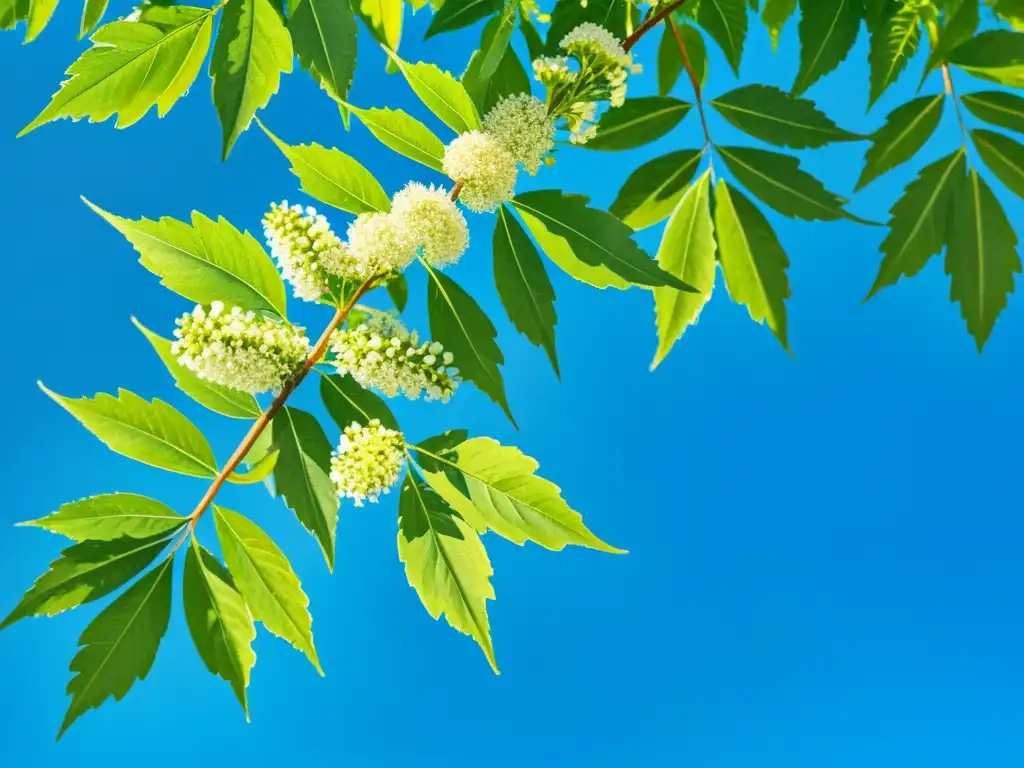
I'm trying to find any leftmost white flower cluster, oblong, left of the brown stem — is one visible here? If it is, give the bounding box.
[171,301,309,394]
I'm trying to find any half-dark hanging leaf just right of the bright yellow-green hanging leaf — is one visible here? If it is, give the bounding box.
[715,179,791,350]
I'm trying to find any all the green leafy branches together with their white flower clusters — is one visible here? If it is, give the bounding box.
[0,0,1024,733]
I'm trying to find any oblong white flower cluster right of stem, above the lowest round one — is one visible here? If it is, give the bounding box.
[331,315,459,402]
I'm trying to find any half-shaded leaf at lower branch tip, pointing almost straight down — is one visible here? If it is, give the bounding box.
[181,540,252,722]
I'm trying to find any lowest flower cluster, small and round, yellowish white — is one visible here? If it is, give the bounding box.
[331,419,406,507]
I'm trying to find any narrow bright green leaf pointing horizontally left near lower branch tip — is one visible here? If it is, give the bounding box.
[18,494,185,542]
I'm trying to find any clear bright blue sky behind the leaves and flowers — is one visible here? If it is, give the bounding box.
[0,2,1024,768]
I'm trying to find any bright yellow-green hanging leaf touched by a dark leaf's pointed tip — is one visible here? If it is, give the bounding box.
[650,170,716,370]
